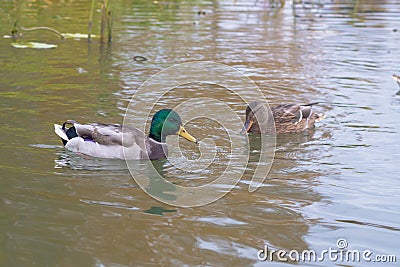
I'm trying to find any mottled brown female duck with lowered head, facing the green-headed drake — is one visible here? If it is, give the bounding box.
[242,101,325,134]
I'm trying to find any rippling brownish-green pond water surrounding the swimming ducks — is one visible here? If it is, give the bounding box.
[0,0,400,266]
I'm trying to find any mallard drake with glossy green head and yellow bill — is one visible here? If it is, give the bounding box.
[54,109,197,159]
